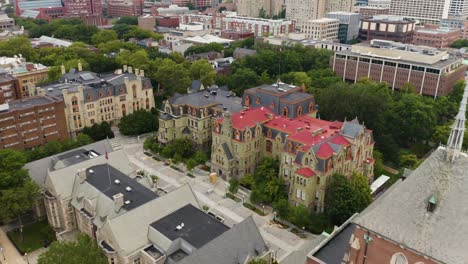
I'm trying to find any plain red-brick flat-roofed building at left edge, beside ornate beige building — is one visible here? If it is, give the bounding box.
[0,95,68,149]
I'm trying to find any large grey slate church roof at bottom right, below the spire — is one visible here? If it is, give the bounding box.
[354,147,468,264]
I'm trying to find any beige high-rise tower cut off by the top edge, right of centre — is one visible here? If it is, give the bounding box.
[285,0,325,24]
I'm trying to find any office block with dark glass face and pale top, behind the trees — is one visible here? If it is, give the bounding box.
[325,12,360,43]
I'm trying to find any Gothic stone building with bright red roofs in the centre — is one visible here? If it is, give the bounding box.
[211,107,374,212]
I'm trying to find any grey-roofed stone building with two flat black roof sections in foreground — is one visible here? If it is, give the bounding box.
[44,150,273,264]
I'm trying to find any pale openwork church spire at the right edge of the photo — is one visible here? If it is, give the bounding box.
[447,80,468,162]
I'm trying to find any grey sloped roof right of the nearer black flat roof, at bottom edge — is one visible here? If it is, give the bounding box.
[178,216,268,264]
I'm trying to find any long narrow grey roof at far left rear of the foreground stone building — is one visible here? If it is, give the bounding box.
[24,139,113,188]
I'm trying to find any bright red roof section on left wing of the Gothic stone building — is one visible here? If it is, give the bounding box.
[218,107,273,130]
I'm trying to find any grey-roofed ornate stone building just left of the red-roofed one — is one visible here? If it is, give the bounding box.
[158,81,242,149]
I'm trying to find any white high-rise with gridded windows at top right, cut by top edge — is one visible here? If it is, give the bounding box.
[390,0,450,24]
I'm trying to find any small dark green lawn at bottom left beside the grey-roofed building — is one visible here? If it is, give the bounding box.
[8,220,55,254]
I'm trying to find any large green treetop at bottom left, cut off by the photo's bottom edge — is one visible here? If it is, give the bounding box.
[38,234,107,264]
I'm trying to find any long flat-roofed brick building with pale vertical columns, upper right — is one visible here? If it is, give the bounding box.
[330,40,466,98]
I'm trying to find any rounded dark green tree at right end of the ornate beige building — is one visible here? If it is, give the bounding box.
[118,110,158,135]
